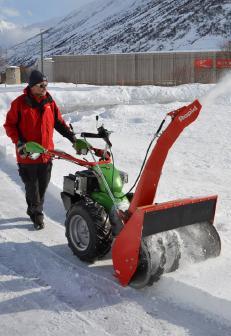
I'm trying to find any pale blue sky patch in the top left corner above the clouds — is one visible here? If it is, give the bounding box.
[0,0,93,25]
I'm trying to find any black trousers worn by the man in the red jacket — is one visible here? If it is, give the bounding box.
[18,162,52,215]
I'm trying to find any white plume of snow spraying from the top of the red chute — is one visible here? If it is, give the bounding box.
[200,73,231,106]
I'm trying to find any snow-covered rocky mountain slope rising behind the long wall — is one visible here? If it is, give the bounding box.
[10,0,231,65]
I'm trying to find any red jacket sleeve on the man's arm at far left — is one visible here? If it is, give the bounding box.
[3,99,19,144]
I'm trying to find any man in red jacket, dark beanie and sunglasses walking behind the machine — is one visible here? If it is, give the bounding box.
[4,70,76,230]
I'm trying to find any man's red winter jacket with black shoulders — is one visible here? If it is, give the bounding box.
[4,87,74,164]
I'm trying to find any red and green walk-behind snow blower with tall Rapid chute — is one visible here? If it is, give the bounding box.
[26,100,221,288]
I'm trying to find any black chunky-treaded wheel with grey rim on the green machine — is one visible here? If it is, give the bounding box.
[65,201,112,262]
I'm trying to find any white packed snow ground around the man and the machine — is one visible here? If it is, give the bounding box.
[0,77,231,336]
